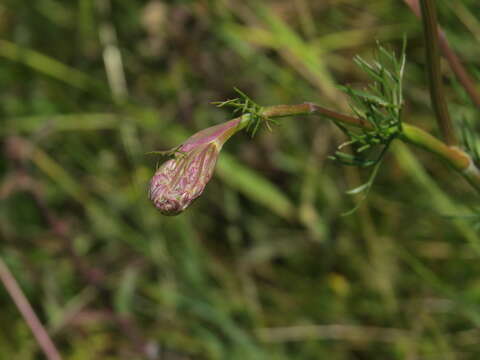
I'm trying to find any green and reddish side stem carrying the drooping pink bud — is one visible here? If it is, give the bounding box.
[262,103,480,192]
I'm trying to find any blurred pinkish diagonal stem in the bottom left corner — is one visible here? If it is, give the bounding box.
[0,258,62,360]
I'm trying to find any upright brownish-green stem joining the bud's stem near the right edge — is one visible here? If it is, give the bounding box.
[420,0,457,145]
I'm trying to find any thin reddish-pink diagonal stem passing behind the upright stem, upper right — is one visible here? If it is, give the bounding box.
[403,0,480,108]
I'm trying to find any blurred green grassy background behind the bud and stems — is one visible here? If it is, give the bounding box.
[0,0,480,360]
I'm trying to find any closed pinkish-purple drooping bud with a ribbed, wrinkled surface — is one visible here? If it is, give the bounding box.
[149,118,243,215]
